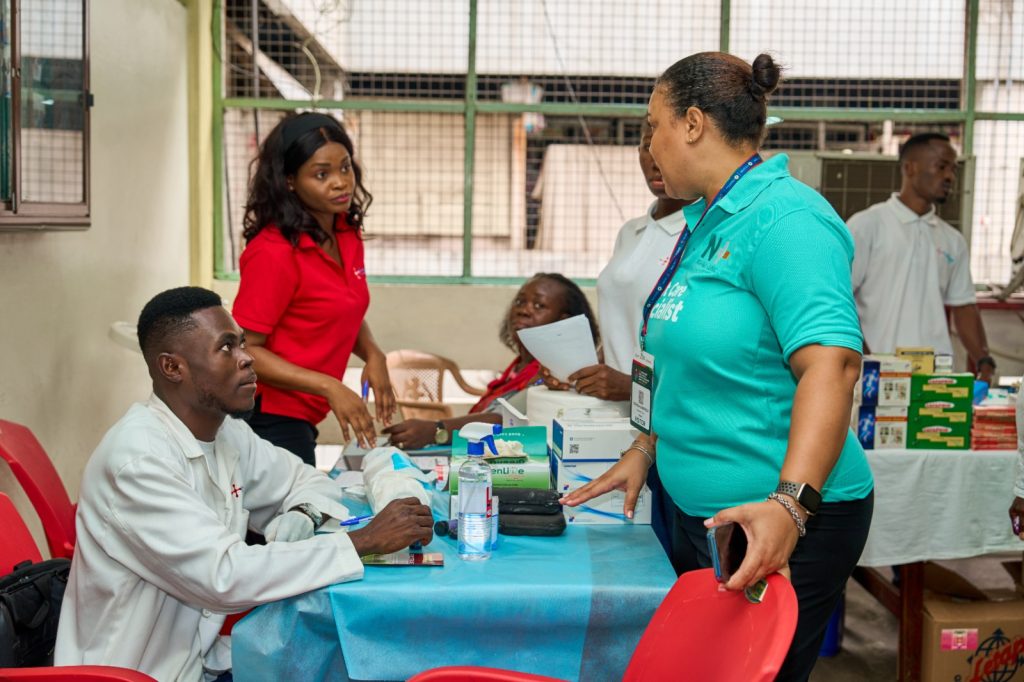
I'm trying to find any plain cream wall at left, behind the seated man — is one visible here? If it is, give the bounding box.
[0,0,188,544]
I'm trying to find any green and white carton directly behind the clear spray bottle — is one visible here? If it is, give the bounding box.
[449,426,551,495]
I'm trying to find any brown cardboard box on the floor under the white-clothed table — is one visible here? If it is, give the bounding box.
[921,562,1024,682]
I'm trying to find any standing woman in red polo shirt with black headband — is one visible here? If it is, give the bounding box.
[232,114,394,464]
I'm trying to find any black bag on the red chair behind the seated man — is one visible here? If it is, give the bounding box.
[0,559,71,668]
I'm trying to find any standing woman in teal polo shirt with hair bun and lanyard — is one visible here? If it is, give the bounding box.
[564,52,873,680]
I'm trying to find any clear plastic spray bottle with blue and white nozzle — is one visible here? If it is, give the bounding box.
[459,423,501,561]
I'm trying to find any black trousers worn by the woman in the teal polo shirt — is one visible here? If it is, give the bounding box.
[673,493,874,682]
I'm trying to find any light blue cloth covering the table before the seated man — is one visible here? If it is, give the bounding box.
[231,525,675,682]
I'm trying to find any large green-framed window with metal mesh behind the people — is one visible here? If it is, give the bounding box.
[212,0,1024,283]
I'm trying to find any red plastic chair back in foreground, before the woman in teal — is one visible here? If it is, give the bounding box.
[623,568,797,682]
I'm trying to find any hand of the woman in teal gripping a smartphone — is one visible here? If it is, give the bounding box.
[705,500,806,590]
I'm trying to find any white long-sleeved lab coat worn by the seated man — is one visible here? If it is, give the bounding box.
[54,396,362,682]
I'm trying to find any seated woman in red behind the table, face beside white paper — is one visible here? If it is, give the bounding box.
[383,272,599,450]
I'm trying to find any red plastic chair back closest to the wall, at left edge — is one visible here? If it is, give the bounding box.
[0,419,75,559]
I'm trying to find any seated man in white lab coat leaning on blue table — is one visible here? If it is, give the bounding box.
[55,287,432,681]
